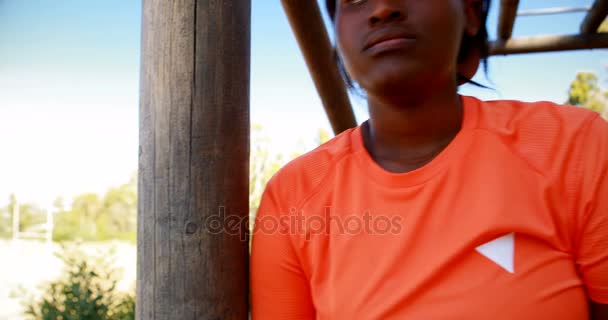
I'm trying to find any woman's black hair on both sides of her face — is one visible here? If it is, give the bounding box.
[325,0,491,90]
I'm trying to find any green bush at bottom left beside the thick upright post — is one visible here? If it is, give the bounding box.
[24,247,135,320]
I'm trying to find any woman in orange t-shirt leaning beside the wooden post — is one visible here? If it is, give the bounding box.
[251,0,608,320]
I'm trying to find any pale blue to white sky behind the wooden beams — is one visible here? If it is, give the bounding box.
[0,0,608,204]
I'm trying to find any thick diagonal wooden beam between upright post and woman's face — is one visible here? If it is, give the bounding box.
[281,0,357,134]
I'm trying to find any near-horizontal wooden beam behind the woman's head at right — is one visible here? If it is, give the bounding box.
[490,33,608,55]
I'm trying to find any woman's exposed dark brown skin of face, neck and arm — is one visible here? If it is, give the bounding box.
[334,0,608,320]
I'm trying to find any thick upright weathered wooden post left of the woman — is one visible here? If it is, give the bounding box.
[136,0,251,320]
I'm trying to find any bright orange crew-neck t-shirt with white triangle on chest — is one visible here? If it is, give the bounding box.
[251,97,608,320]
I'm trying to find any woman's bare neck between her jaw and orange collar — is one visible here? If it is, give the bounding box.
[363,86,464,172]
